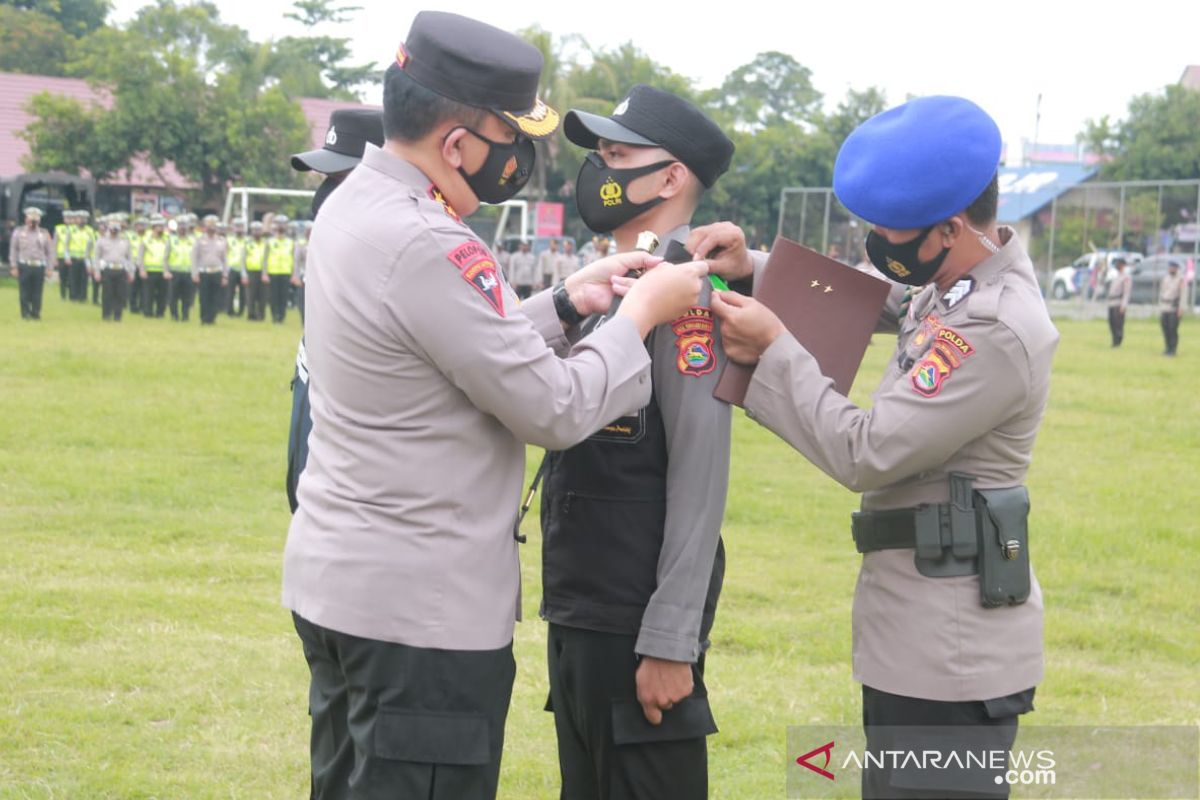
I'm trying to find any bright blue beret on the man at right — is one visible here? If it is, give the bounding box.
[833,96,1001,230]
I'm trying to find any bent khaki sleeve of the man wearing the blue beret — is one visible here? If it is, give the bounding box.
[745,325,1032,492]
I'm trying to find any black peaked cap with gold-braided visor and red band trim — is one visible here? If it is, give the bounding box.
[396,11,558,139]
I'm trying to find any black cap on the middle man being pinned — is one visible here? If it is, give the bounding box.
[563,84,733,187]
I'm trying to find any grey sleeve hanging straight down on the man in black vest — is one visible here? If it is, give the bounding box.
[638,287,731,662]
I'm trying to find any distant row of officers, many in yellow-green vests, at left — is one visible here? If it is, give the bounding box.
[8,207,312,325]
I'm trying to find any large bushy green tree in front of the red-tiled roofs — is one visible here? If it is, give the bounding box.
[24,0,308,200]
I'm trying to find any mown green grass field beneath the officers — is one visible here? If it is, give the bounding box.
[0,281,1200,800]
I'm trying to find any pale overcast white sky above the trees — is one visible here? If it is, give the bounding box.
[113,0,1200,163]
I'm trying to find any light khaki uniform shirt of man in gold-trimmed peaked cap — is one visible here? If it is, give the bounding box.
[283,145,650,650]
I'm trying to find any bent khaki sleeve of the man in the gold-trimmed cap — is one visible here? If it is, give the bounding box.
[384,231,650,450]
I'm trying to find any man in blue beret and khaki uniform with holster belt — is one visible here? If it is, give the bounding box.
[689,97,1058,798]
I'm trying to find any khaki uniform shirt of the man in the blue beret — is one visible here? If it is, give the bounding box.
[745,228,1058,700]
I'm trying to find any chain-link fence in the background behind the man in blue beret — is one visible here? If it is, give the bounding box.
[778,180,1200,303]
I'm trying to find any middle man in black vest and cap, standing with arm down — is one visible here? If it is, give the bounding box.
[541,85,733,800]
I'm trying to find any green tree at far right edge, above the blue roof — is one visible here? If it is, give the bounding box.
[1079,85,1200,181]
